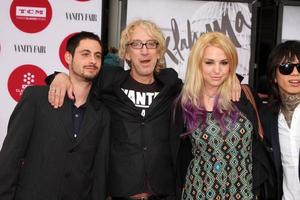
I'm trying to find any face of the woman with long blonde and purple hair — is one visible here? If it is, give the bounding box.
[201,46,230,92]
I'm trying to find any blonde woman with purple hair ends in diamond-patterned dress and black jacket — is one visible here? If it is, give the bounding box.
[177,32,271,200]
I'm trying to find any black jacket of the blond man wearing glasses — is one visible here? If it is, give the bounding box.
[97,67,182,197]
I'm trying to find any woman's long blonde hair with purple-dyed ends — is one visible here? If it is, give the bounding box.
[179,32,238,132]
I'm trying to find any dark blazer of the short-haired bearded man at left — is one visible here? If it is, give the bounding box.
[0,86,110,200]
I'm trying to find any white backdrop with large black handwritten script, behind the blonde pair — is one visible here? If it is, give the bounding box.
[127,0,252,83]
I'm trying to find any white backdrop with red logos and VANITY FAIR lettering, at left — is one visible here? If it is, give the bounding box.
[0,0,102,148]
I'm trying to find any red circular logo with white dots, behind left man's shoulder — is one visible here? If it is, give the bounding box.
[7,64,47,101]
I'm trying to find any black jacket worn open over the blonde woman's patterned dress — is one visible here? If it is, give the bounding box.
[172,86,275,200]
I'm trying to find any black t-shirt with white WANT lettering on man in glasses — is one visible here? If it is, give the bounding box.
[122,76,162,117]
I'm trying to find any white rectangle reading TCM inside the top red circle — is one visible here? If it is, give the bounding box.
[16,6,47,20]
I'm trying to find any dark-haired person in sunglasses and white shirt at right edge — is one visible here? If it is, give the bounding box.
[261,40,300,200]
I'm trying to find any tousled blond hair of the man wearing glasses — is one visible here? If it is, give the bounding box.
[119,19,166,73]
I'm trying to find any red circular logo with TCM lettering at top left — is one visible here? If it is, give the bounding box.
[10,0,52,33]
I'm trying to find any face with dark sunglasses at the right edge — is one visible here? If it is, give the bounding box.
[275,59,300,94]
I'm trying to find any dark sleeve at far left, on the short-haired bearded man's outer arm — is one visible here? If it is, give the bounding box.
[0,87,36,200]
